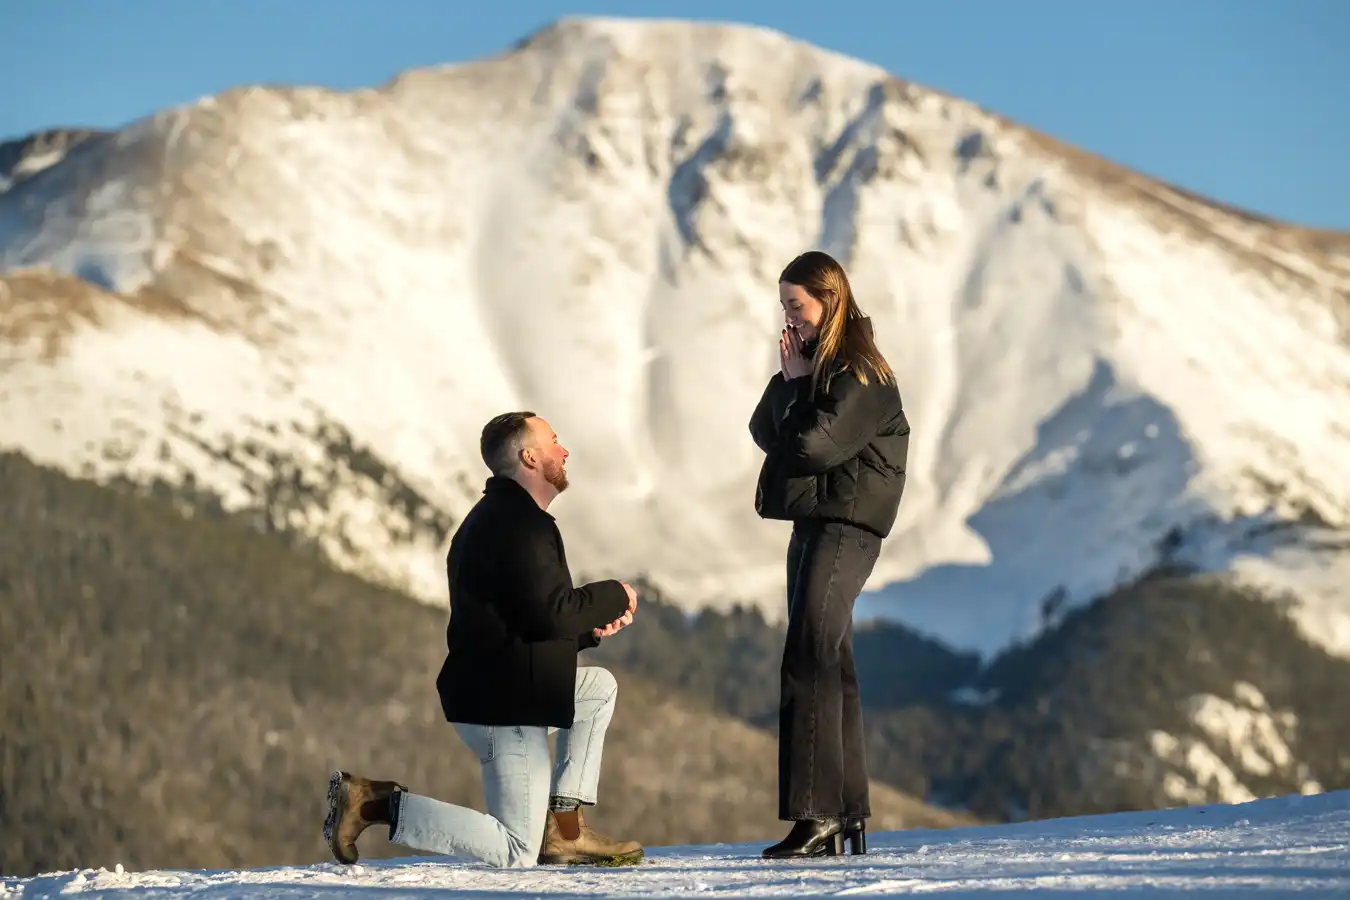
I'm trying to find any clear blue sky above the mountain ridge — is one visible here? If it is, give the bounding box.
[0,0,1350,229]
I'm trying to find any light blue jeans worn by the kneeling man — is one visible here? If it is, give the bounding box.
[389,667,618,868]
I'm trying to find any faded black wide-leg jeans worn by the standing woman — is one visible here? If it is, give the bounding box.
[778,521,882,822]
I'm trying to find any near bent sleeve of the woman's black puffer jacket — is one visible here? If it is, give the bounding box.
[778,371,880,475]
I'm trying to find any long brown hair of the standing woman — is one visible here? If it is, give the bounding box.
[778,250,895,390]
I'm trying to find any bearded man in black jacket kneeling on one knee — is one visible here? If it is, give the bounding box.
[324,412,643,868]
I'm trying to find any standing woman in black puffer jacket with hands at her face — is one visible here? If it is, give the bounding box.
[751,251,910,858]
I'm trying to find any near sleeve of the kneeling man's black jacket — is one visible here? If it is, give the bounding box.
[495,524,628,649]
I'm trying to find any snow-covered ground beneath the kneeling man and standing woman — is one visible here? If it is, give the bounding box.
[0,791,1350,900]
